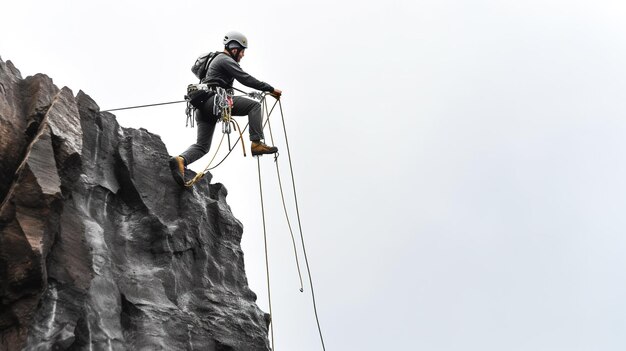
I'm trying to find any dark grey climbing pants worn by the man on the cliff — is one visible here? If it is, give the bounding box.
[180,96,263,165]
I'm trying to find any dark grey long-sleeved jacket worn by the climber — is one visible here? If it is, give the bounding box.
[202,54,274,92]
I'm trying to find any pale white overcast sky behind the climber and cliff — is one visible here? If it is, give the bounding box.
[0,0,626,351]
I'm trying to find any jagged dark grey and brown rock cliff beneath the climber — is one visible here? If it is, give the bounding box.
[0,59,270,351]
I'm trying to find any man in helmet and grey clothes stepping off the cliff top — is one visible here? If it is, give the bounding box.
[169,32,282,185]
